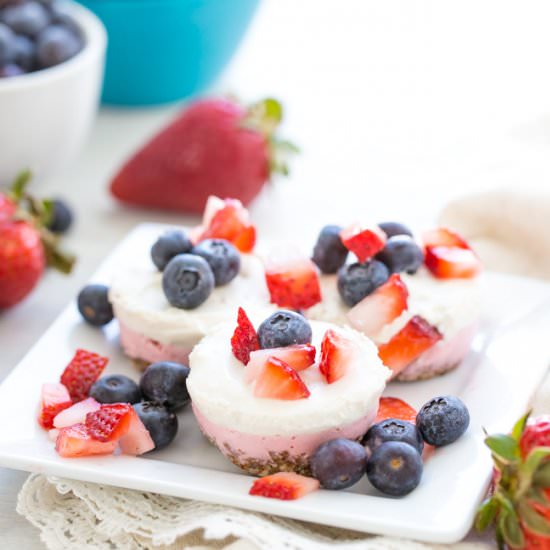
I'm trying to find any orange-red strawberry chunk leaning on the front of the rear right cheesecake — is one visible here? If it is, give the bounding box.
[378,315,442,376]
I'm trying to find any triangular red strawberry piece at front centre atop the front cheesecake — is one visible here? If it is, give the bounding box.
[254,357,309,401]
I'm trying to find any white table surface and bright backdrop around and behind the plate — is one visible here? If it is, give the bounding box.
[0,0,550,550]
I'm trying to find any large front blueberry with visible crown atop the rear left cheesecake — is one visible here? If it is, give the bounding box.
[162,254,215,309]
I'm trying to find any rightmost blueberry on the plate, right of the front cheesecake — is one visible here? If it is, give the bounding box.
[416,395,470,447]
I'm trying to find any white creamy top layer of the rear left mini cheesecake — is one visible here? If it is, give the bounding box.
[109,254,274,346]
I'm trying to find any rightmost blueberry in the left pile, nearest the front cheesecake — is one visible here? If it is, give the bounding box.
[139,361,190,411]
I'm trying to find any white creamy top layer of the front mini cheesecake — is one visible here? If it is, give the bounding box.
[187,318,391,436]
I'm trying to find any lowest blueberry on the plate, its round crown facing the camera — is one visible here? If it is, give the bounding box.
[367,441,423,497]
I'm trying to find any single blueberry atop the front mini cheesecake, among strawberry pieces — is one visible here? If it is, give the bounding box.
[258,309,311,349]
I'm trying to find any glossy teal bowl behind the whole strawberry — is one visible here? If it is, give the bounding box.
[76,0,259,106]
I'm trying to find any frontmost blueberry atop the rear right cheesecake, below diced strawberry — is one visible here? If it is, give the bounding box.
[338,260,390,307]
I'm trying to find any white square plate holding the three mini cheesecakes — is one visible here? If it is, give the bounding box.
[0,224,550,543]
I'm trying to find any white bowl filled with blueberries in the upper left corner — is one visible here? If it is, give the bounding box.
[0,4,107,185]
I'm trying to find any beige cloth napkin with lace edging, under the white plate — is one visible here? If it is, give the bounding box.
[17,190,550,550]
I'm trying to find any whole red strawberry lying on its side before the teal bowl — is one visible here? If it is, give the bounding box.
[111,99,296,212]
